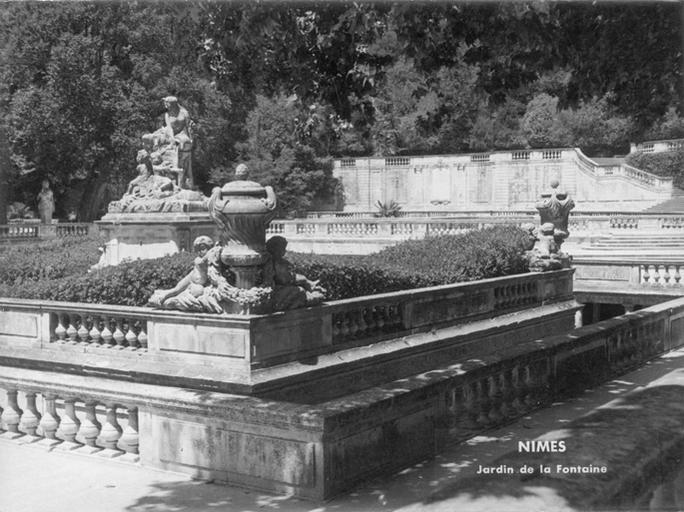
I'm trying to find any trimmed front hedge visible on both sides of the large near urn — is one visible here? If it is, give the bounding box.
[0,226,528,306]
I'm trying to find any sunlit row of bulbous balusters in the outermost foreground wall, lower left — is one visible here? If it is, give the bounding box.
[0,382,139,462]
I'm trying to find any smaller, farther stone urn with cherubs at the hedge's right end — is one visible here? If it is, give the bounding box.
[526,180,575,272]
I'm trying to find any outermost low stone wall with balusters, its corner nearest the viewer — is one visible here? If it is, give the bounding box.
[0,298,684,499]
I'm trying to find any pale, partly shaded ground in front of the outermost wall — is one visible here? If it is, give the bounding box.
[0,349,684,512]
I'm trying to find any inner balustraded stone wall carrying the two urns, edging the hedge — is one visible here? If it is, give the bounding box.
[0,270,578,392]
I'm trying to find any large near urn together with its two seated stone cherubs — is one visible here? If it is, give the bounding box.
[149,164,325,314]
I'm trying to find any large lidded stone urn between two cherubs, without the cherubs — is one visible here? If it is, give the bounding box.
[209,166,276,289]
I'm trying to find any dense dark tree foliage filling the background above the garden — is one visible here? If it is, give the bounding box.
[0,1,684,220]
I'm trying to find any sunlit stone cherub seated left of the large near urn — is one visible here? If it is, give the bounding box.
[148,236,223,313]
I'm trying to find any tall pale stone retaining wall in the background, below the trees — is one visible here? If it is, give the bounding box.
[334,148,672,211]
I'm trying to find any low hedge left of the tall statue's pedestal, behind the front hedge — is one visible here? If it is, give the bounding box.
[0,235,104,285]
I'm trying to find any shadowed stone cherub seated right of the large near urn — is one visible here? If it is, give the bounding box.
[263,236,326,311]
